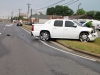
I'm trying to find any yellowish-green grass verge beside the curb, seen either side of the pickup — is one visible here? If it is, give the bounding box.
[23,24,100,55]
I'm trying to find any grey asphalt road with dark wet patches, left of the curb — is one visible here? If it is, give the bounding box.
[0,23,100,75]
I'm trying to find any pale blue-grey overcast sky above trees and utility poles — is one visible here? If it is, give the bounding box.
[0,0,100,18]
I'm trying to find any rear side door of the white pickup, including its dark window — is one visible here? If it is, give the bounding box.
[52,20,64,38]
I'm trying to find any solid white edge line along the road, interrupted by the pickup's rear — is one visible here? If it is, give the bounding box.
[21,27,96,61]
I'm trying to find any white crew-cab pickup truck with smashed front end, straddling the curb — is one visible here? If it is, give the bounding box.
[31,19,98,42]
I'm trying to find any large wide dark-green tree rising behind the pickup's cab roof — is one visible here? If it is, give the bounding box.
[47,5,74,16]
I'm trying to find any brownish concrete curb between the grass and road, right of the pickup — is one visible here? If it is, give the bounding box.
[55,41,100,58]
